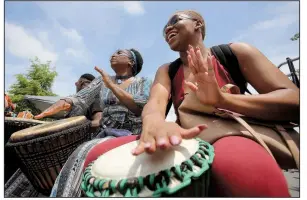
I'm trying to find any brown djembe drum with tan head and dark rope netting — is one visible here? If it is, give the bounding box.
[7,116,91,195]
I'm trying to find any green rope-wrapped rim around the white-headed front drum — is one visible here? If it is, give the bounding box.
[81,138,214,197]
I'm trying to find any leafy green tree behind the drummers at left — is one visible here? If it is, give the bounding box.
[8,57,57,115]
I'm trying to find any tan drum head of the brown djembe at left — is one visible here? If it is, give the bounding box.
[10,116,87,143]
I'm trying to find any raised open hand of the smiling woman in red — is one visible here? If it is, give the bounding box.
[185,45,224,106]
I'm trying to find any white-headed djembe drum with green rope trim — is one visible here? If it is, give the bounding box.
[81,136,214,197]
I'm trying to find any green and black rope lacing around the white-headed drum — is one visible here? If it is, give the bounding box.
[81,138,214,197]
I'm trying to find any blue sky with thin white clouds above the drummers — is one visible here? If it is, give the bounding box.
[5,1,299,122]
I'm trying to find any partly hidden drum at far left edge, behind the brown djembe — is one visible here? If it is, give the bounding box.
[4,117,48,182]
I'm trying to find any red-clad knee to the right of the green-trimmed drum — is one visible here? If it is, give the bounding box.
[212,136,289,197]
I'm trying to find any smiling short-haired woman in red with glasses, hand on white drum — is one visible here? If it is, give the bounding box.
[132,11,299,197]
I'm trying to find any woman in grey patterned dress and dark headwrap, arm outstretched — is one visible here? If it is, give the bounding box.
[35,49,152,137]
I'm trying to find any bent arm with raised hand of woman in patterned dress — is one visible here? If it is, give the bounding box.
[109,78,152,116]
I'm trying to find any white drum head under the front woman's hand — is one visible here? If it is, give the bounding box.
[91,139,199,180]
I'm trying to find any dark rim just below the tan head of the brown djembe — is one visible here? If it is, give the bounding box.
[6,120,91,147]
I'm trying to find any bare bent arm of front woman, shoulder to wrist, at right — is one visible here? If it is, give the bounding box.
[217,43,299,121]
